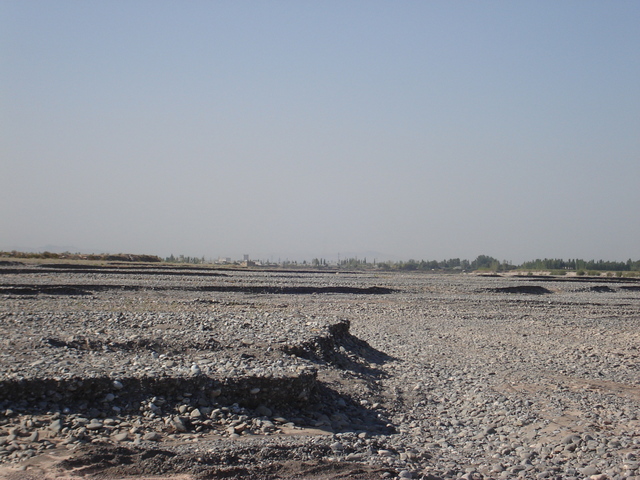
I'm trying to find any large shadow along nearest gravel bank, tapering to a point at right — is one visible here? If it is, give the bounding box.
[0,371,394,434]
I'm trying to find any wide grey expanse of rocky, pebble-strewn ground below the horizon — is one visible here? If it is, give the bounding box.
[0,262,640,479]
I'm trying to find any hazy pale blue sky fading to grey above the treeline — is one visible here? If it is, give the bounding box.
[0,0,640,263]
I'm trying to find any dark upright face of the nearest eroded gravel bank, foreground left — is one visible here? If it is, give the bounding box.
[0,370,317,415]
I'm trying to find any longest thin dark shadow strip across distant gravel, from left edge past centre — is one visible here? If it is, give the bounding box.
[0,284,395,295]
